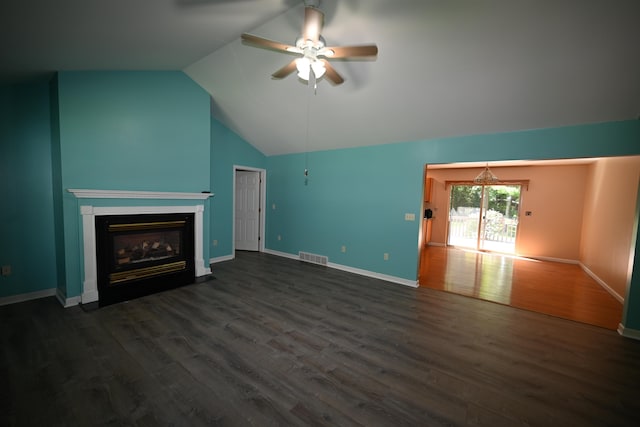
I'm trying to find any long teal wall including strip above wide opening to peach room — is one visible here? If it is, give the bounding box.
[267,120,640,300]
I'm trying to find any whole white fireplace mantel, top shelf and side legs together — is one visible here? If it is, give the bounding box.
[68,190,213,304]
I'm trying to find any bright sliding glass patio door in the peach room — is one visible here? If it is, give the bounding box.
[447,183,521,254]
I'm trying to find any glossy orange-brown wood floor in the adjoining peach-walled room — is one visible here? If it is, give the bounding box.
[419,246,623,330]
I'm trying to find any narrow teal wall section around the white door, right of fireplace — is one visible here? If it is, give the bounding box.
[208,118,269,258]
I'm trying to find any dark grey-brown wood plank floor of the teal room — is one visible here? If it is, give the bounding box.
[0,253,640,426]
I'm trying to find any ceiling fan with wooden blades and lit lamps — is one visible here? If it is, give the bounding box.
[242,2,378,85]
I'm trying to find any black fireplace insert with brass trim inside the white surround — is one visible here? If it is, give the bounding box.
[95,213,195,307]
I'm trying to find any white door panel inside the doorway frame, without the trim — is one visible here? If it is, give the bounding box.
[235,170,260,251]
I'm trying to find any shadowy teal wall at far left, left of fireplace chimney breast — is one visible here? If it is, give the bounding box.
[0,81,57,297]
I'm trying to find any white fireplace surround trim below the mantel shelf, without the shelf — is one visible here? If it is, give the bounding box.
[80,205,211,304]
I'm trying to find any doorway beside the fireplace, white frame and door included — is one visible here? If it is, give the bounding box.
[233,166,266,252]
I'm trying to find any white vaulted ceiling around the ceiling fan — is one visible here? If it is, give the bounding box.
[0,0,640,155]
